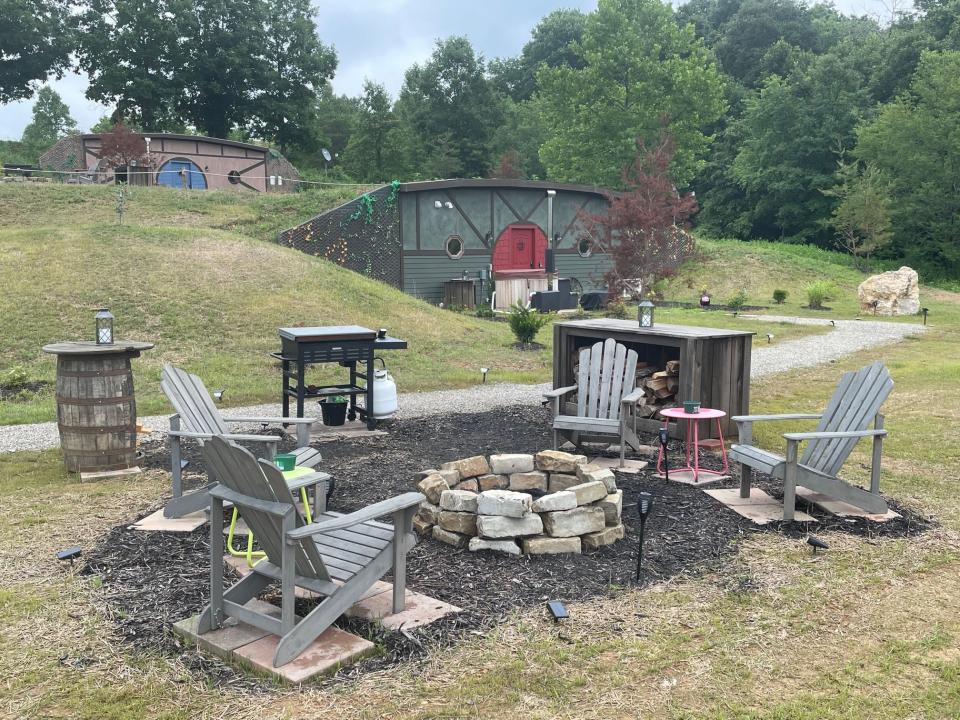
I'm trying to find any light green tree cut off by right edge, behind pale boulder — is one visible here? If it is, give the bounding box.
[854,51,960,278]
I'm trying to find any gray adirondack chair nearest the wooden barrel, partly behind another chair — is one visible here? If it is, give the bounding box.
[160,365,322,517]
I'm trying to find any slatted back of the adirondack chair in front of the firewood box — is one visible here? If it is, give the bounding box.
[577,338,637,420]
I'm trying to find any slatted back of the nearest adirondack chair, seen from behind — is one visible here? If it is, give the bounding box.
[202,437,330,580]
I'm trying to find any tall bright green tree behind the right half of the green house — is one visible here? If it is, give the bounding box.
[537,0,725,187]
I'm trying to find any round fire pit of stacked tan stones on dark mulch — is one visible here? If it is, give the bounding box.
[414,450,624,555]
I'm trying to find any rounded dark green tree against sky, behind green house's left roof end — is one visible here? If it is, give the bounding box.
[396,37,502,177]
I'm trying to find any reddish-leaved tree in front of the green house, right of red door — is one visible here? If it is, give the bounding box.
[579,130,698,295]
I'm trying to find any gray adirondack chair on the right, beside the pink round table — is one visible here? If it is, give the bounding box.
[730,362,893,521]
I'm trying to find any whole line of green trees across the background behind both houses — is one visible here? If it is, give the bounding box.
[0,0,960,278]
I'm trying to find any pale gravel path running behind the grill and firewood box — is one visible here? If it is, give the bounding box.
[0,315,925,452]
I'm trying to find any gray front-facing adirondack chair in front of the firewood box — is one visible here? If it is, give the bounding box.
[543,338,644,467]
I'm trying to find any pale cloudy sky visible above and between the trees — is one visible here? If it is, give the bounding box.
[0,0,892,140]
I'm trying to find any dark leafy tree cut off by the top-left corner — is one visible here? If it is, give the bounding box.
[0,0,73,105]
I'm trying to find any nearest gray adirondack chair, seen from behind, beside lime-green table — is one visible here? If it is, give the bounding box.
[198,437,424,667]
